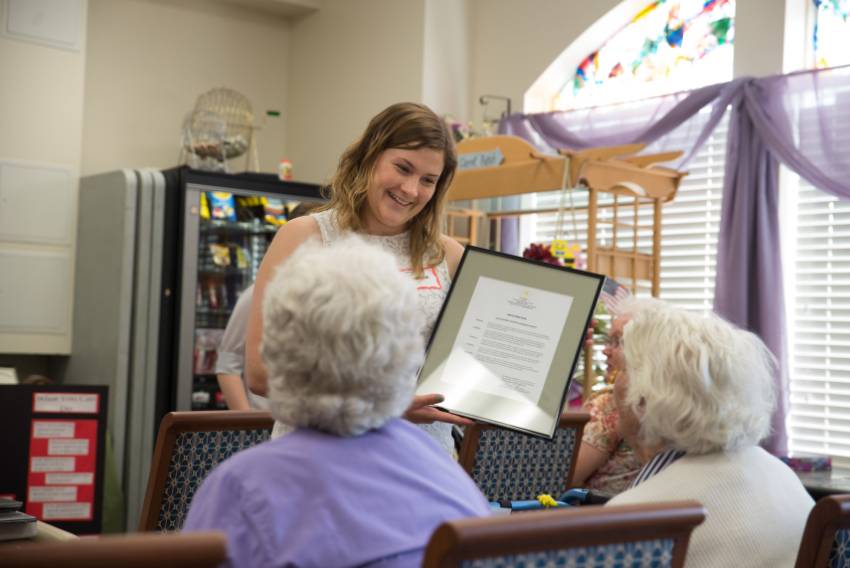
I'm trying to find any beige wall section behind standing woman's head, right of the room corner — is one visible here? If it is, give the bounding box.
[283,0,425,182]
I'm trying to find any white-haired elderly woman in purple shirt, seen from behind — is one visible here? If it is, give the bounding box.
[184,237,489,568]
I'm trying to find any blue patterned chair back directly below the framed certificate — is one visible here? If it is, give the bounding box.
[460,412,590,501]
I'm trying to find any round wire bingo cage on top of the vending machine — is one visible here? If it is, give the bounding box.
[181,88,258,172]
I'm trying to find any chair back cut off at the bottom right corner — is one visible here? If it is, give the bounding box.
[796,495,850,568]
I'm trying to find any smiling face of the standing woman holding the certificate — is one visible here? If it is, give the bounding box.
[363,148,443,235]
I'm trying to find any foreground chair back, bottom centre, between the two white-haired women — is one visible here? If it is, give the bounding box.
[422,501,705,568]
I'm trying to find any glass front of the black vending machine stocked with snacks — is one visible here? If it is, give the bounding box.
[174,169,322,410]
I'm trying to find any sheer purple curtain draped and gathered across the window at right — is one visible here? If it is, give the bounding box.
[500,67,850,454]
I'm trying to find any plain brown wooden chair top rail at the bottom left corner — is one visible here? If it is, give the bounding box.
[0,532,227,568]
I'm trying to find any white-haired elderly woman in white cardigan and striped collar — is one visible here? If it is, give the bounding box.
[609,301,814,568]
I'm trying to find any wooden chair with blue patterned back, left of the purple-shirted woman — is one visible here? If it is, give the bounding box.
[139,411,274,531]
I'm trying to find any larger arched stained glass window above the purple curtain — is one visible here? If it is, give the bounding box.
[552,0,735,109]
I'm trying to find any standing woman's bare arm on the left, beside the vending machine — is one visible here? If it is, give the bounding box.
[245,216,319,396]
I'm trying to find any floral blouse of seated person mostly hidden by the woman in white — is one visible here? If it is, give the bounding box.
[582,392,641,495]
